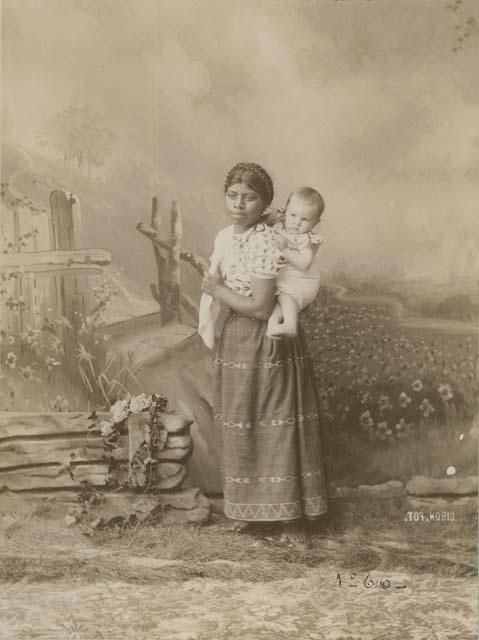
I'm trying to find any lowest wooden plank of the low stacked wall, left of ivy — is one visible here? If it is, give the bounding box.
[0,463,108,491]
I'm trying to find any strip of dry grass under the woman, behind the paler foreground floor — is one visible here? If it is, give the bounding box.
[0,495,477,583]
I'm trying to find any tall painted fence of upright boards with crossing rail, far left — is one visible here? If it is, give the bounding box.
[0,189,111,334]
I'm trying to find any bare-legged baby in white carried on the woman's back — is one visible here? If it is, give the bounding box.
[267,187,324,338]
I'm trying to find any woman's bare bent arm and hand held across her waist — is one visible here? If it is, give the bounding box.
[201,274,276,320]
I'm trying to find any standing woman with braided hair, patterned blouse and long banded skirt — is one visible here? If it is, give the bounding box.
[202,163,327,529]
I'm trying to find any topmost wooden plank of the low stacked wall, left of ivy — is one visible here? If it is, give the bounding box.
[0,411,110,441]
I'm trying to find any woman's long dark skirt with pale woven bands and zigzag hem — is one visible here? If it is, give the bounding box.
[213,312,327,521]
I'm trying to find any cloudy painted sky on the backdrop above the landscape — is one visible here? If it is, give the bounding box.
[2,0,479,274]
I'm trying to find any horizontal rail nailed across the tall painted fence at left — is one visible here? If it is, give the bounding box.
[0,249,111,273]
